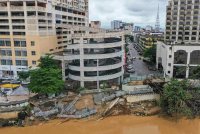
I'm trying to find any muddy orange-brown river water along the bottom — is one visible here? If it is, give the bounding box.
[0,116,200,134]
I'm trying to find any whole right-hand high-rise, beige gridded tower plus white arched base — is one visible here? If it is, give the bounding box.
[157,0,200,78]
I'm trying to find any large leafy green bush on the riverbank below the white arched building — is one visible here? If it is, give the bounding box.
[160,79,192,117]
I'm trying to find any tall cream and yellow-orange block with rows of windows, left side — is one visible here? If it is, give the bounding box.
[0,0,89,78]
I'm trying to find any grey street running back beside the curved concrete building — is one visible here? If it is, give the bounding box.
[128,44,156,75]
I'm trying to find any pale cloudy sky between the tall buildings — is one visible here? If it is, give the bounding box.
[89,0,168,28]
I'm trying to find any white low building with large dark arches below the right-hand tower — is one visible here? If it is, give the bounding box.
[157,42,200,78]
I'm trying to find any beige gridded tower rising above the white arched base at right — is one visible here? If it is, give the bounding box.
[165,0,200,44]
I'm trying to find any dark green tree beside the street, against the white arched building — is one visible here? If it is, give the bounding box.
[143,44,156,63]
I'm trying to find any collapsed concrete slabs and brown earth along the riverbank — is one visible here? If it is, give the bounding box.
[0,89,160,125]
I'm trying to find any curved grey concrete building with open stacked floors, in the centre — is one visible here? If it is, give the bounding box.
[55,32,125,89]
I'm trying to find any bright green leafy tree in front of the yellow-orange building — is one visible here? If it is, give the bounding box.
[29,55,64,94]
